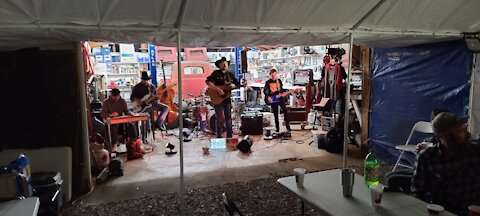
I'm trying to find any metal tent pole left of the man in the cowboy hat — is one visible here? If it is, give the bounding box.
[177,31,185,215]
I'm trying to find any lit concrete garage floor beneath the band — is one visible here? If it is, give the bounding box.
[79,125,363,204]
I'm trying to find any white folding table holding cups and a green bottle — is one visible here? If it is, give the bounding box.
[278,169,453,216]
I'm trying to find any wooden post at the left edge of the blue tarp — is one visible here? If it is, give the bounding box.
[360,47,372,148]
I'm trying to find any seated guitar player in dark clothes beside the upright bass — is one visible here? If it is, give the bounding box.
[130,71,168,131]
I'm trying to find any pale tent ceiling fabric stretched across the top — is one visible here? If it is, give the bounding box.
[0,0,480,50]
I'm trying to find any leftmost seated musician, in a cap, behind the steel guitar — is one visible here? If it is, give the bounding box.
[100,88,143,159]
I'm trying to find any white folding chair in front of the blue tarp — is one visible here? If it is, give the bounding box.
[392,121,433,171]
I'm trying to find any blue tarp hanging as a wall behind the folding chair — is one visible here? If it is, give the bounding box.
[369,40,473,164]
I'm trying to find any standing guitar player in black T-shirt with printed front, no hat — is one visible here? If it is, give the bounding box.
[263,68,291,136]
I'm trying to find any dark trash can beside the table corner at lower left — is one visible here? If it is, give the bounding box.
[32,172,64,216]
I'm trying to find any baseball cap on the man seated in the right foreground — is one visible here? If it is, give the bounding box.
[431,112,468,135]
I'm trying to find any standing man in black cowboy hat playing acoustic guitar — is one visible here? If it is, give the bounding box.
[205,57,240,138]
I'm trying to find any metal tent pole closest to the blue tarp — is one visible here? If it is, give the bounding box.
[343,33,353,168]
